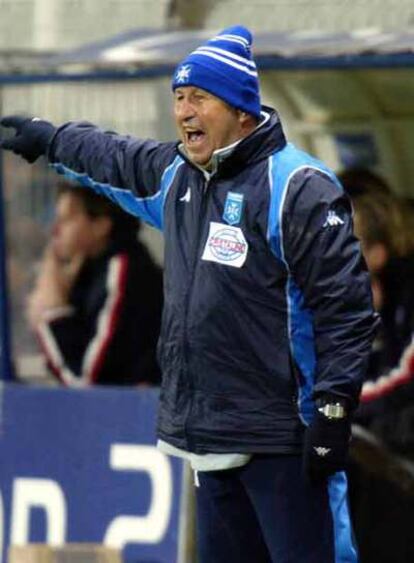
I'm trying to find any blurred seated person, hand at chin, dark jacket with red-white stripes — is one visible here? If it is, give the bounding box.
[27,183,162,387]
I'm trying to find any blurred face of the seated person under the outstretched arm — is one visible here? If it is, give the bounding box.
[52,193,107,260]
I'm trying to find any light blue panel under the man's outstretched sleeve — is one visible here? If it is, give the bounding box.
[51,156,184,230]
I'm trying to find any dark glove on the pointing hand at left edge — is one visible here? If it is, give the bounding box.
[0,115,56,163]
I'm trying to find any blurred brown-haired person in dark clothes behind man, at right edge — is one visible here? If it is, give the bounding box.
[340,170,414,563]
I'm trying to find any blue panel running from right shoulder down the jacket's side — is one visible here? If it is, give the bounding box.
[267,143,340,424]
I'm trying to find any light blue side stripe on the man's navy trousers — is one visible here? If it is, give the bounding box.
[328,471,358,563]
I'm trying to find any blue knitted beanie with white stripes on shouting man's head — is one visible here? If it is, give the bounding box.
[172,25,260,118]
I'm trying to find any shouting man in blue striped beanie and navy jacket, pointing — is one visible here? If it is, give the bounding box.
[2,26,377,563]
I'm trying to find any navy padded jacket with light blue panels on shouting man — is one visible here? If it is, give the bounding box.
[49,108,376,453]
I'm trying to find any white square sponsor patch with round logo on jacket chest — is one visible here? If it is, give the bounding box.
[201,221,249,268]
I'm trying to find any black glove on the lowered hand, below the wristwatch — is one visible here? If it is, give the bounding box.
[303,409,351,482]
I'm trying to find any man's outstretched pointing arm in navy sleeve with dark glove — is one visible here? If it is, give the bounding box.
[0,116,183,229]
